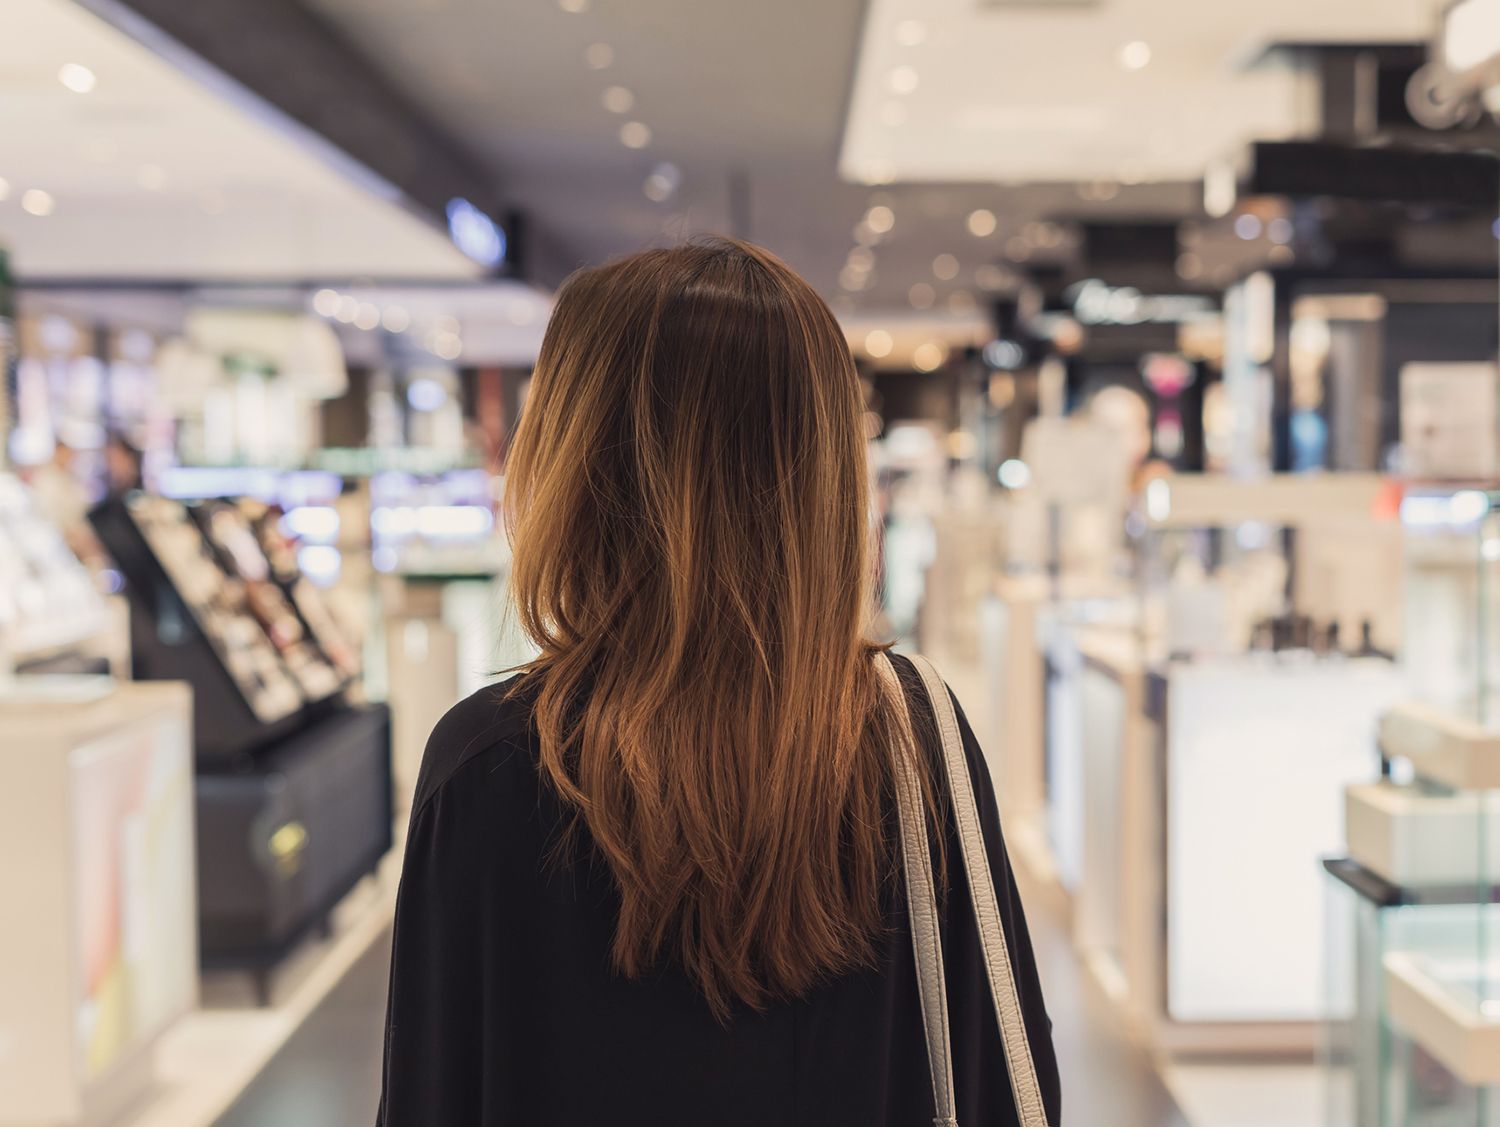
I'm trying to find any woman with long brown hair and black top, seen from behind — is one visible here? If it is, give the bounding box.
[381,239,1059,1127]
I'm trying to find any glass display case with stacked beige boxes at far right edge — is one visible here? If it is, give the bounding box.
[1325,489,1500,1127]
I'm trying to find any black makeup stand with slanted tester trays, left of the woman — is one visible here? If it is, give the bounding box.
[90,494,393,996]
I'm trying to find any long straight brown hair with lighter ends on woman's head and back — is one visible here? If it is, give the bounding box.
[506,239,905,1017]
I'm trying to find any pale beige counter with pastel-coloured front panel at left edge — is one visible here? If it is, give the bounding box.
[0,678,198,1124]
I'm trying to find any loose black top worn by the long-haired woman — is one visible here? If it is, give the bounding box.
[380,657,1059,1127]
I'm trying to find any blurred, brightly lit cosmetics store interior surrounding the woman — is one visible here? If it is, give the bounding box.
[0,0,1500,1127]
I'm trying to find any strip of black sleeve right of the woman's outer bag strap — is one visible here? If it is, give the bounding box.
[948,689,1062,1127]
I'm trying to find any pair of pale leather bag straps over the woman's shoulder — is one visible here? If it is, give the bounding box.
[884,654,1047,1127]
